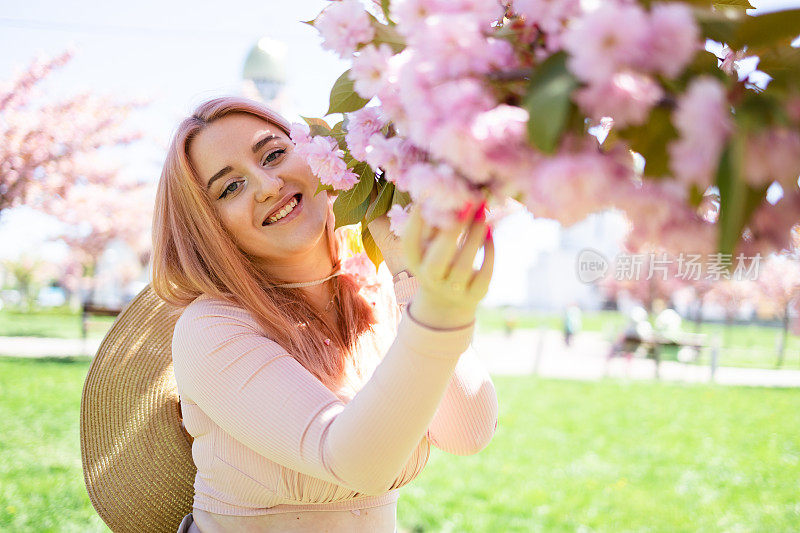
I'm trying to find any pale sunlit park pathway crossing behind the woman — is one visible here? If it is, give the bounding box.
[0,330,800,387]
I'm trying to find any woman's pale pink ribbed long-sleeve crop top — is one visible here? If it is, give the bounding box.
[172,272,498,516]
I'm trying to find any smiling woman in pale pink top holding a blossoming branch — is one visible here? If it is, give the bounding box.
[153,97,497,533]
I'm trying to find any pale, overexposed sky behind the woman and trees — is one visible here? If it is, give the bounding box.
[0,0,800,306]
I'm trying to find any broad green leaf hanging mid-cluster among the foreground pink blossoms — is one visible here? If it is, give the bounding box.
[523,52,578,153]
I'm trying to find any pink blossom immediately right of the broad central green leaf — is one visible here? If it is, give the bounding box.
[575,71,664,127]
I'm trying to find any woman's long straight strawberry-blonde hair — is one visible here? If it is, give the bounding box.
[152,97,376,392]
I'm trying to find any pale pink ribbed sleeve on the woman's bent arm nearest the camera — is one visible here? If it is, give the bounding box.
[173,290,474,495]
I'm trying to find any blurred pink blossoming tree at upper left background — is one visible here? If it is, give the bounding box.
[0,51,145,218]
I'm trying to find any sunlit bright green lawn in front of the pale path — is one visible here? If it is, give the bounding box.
[0,358,800,533]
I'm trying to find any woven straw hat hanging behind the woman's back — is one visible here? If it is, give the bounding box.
[80,285,197,533]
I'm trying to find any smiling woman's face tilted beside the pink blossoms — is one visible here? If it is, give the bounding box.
[189,113,328,266]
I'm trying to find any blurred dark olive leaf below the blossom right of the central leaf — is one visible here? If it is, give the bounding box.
[619,107,678,178]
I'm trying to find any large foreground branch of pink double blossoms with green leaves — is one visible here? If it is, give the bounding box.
[292,0,800,272]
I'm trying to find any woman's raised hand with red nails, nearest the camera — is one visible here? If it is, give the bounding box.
[402,204,494,328]
